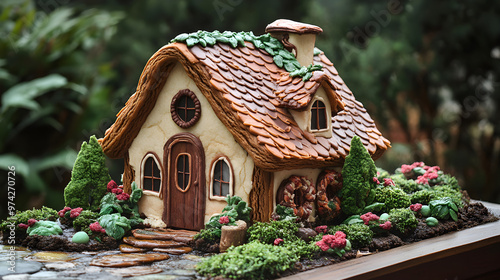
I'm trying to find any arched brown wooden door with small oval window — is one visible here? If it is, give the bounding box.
[163,133,205,230]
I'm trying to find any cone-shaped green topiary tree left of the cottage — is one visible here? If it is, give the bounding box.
[64,136,111,211]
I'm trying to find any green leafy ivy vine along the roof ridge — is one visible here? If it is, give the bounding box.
[170,30,322,81]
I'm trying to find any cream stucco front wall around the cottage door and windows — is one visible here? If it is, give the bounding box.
[129,63,254,222]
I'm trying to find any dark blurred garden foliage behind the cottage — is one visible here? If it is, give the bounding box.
[0,0,500,218]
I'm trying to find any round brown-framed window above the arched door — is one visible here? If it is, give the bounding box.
[170,89,201,128]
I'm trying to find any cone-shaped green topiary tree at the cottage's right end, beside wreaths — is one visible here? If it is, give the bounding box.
[339,136,377,215]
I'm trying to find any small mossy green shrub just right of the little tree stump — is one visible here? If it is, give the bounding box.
[247,220,300,244]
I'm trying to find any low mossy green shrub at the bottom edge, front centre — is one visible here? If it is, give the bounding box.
[196,241,299,279]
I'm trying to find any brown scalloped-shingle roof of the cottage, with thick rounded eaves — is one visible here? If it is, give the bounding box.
[100,19,390,171]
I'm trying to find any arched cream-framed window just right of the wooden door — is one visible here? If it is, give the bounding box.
[210,157,233,199]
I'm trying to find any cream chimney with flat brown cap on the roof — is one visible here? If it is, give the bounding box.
[266,19,323,66]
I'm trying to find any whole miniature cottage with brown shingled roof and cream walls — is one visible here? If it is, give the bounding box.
[100,20,390,230]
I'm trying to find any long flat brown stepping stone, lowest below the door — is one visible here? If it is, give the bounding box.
[90,253,170,267]
